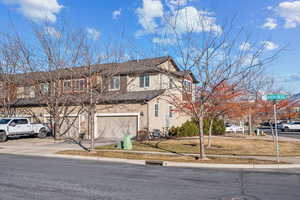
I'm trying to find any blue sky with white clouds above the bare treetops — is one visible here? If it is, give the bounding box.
[0,0,300,93]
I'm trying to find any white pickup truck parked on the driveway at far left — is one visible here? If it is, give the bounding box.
[0,118,50,142]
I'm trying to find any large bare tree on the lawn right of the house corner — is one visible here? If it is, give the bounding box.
[138,10,281,159]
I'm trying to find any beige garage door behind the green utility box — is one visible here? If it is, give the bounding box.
[95,113,139,140]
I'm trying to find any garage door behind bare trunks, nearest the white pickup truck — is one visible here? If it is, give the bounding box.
[45,116,80,138]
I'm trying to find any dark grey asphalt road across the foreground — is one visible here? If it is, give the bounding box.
[0,154,300,200]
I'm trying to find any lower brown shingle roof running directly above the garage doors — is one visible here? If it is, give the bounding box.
[11,90,165,107]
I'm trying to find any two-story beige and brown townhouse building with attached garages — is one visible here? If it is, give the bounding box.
[0,57,197,138]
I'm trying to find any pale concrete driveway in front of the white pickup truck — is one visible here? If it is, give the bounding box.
[0,137,114,156]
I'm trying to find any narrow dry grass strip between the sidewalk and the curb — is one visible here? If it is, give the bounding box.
[59,150,283,164]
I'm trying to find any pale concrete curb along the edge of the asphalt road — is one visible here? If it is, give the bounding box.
[15,154,300,169]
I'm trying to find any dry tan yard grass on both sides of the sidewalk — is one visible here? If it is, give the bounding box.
[59,136,300,164]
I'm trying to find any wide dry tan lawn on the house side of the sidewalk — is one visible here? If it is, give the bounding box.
[96,137,300,156]
